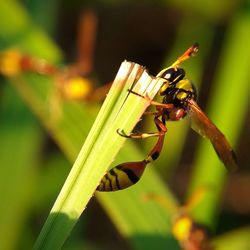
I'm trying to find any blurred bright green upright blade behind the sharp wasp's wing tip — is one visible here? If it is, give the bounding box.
[188,11,250,227]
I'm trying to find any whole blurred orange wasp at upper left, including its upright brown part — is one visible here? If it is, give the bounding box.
[0,10,110,105]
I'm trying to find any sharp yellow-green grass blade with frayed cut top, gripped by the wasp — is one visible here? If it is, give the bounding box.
[34,62,166,249]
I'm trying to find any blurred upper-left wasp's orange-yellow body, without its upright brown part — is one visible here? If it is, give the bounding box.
[0,48,97,101]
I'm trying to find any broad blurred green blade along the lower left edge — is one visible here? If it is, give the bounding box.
[0,85,41,249]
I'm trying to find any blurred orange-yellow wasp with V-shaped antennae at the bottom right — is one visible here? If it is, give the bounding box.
[144,187,214,250]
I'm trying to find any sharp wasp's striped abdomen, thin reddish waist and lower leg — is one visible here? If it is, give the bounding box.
[97,117,167,192]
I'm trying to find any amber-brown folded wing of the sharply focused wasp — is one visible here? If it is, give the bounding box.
[187,100,237,171]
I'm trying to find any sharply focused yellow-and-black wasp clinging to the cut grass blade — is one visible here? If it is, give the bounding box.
[97,43,237,191]
